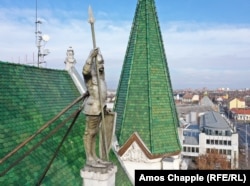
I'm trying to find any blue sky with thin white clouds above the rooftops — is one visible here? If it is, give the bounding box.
[0,0,250,89]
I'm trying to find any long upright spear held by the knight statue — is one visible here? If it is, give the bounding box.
[89,6,109,160]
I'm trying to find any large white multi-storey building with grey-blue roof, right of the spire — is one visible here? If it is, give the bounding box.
[180,111,239,169]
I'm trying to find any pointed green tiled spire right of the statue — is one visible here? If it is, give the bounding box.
[114,0,181,155]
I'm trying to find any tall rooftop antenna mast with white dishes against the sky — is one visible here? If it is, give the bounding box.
[35,0,50,67]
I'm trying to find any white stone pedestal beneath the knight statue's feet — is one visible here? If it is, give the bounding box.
[80,165,117,186]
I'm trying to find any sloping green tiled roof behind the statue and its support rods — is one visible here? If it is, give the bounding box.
[0,61,132,186]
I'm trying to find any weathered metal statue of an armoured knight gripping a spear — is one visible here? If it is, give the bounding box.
[82,48,107,167]
